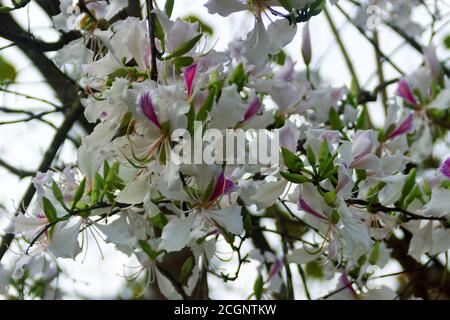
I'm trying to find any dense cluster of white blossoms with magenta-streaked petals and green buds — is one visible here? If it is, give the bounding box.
[0,0,450,299]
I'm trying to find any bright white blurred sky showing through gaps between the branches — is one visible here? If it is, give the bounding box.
[0,0,450,299]
